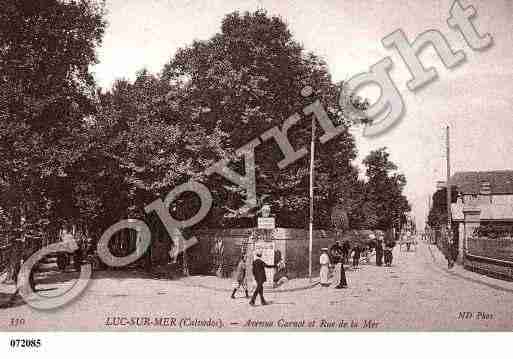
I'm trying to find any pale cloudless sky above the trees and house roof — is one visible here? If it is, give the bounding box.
[92,0,513,231]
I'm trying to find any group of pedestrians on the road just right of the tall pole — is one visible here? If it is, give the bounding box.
[319,233,395,289]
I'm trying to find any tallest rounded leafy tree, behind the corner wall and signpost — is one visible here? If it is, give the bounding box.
[163,10,360,227]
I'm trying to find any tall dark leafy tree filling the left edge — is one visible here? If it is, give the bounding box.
[0,0,105,240]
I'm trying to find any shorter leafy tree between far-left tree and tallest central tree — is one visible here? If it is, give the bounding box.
[87,70,225,233]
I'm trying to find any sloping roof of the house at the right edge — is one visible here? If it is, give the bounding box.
[451,170,513,194]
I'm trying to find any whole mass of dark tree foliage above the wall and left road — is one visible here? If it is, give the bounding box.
[0,6,409,250]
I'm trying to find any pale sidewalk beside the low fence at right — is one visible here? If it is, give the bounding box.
[423,244,513,293]
